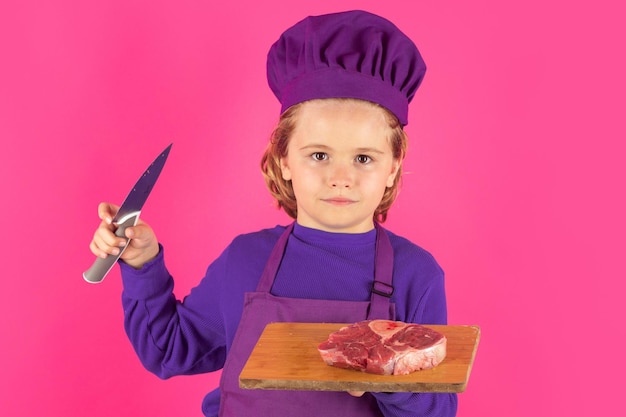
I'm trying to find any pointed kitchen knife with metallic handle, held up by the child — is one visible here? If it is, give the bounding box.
[83,143,173,284]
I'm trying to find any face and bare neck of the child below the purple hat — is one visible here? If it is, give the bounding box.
[281,100,399,233]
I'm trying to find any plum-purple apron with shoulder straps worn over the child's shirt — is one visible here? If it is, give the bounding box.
[219,224,395,417]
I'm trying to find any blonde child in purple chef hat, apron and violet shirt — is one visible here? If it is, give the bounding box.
[91,11,457,417]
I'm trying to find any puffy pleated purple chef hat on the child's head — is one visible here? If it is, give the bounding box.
[267,10,426,125]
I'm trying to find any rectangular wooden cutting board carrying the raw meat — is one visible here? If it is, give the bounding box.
[239,323,480,392]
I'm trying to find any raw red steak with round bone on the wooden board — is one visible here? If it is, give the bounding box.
[318,320,446,375]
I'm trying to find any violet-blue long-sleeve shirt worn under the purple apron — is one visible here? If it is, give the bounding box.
[121,224,457,417]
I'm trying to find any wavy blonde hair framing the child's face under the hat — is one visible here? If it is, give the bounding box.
[261,99,408,223]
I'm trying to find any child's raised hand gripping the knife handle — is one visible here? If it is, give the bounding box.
[89,203,159,269]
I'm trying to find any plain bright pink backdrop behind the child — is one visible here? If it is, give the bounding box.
[0,0,626,417]
